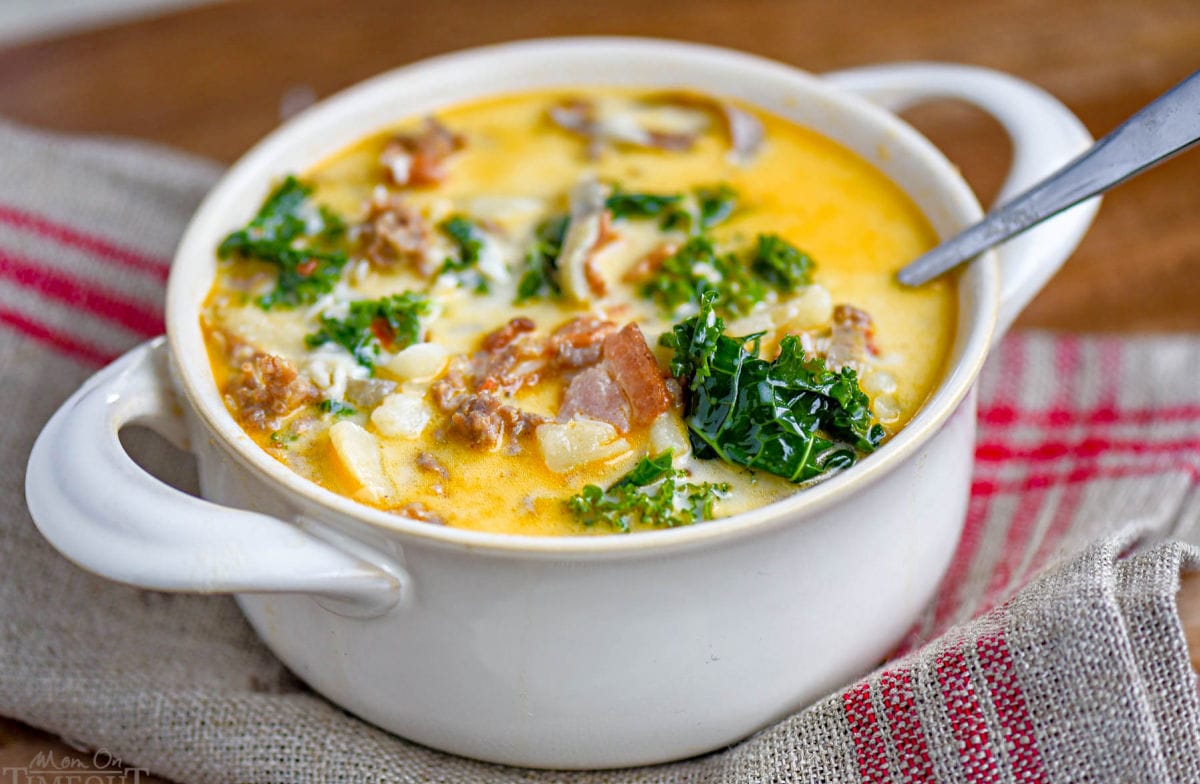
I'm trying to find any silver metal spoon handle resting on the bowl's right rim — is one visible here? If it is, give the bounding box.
[896,71,1200,286]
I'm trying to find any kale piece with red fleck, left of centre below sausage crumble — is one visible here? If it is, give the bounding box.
[305,292,430,370]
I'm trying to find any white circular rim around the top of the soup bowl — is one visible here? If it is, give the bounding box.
[166,36,1000,557]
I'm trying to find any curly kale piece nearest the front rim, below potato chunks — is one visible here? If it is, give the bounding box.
[566,449,730,532]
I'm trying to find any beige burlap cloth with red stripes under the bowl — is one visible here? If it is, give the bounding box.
[0,117,1200,784]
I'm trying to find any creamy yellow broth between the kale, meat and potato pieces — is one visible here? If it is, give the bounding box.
[203,89,955,535]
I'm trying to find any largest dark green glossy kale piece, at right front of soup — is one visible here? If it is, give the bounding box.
[660,292,883,481]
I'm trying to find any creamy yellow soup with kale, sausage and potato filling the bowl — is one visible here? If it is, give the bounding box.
[202,89,956,535]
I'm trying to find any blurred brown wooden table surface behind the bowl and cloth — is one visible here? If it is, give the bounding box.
[0,0,1200,780]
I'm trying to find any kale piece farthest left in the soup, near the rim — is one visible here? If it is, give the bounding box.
[217,175,347,310]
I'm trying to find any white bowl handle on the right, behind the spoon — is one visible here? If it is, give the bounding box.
[824,62,1100,342]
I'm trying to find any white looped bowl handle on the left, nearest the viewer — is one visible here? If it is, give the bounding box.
[25,337,408,616]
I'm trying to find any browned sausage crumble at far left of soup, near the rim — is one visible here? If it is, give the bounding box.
[224,352,320,431]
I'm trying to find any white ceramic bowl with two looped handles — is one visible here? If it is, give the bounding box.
[26,38,1096,767]
